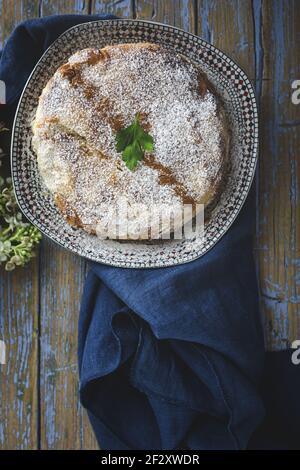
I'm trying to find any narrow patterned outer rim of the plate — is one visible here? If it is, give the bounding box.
[10,19,259,269]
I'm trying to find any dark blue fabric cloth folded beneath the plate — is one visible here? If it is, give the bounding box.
[0,15,299,450]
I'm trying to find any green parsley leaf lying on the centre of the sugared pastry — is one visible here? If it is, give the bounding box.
[116,114,154,171]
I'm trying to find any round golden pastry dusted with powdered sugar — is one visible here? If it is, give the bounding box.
[32,43,230,239]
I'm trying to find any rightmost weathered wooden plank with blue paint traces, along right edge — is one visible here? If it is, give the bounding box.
[255,0,300,349]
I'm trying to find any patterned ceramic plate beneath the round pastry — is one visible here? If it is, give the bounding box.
[11,20,258,268]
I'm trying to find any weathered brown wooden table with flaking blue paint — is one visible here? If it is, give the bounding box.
[0,0,300,449]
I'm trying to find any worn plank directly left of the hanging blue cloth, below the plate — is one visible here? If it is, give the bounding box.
[36,0,97,449]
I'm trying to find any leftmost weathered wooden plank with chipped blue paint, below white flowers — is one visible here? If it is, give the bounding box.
[0,0,39,449]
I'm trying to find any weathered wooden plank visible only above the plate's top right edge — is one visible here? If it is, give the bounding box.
[135,0,196,33]
